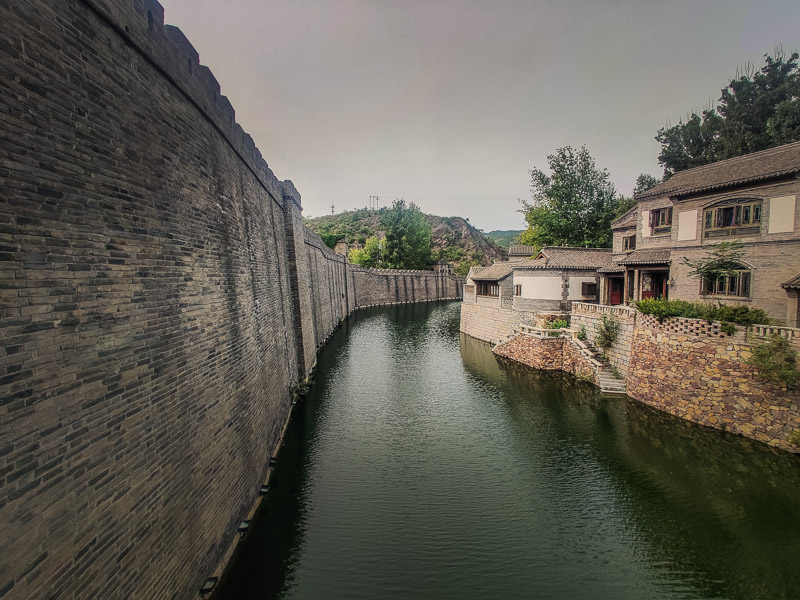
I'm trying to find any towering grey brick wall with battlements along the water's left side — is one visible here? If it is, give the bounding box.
[0,0,460,600]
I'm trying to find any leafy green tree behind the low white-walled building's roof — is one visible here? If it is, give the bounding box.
[519,146,619,248]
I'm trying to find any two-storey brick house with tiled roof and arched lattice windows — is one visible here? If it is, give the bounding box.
[601,142,800,327]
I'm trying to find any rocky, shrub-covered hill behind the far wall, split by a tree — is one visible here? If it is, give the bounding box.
[305,209,505,275]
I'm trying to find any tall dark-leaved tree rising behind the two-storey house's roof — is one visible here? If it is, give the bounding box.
[656,51,800,178]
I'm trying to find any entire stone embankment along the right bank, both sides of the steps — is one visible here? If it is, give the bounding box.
[462,303,800,452]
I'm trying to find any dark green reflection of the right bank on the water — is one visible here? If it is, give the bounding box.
[461,335,800,598]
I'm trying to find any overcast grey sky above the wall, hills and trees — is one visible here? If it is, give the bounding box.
[160,0,800,231]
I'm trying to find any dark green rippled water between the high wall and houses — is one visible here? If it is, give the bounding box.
[214,303,800,600]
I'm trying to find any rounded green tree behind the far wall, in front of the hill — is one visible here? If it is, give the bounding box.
[381,200,431,269]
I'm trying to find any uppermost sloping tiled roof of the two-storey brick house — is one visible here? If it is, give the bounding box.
[636,142,800,199]
